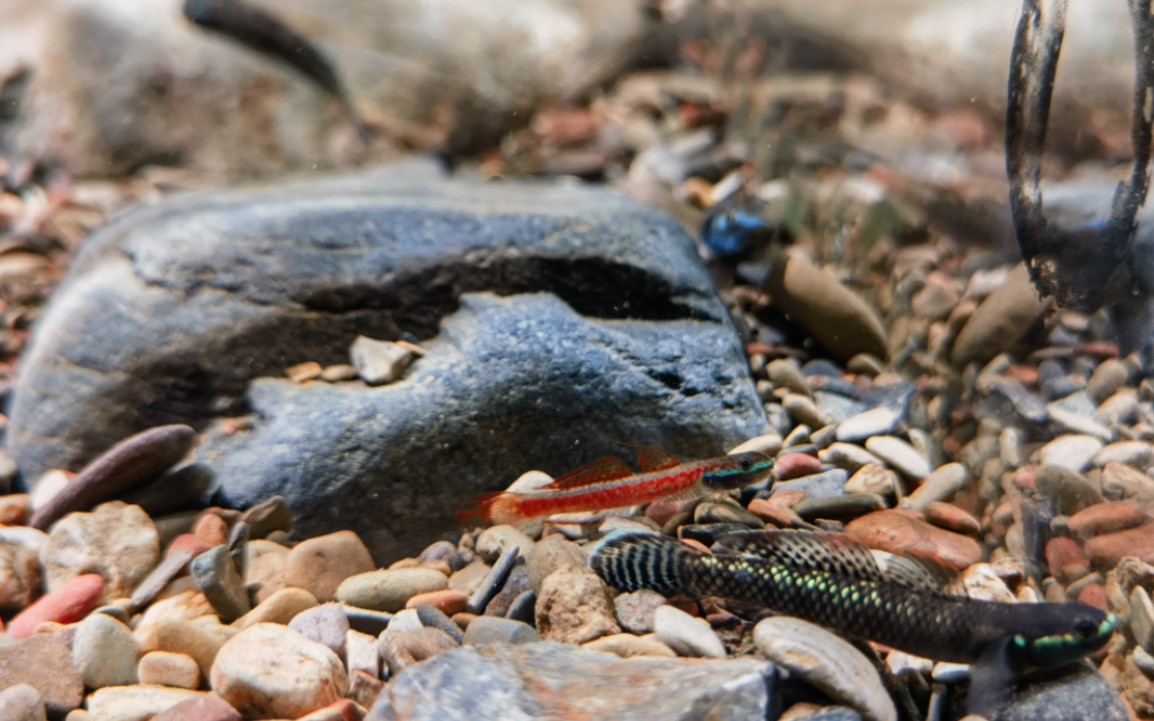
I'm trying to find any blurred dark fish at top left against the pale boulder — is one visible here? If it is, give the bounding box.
[181,0,373,143]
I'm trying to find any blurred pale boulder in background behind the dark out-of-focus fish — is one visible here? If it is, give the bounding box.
[0,0,644,175]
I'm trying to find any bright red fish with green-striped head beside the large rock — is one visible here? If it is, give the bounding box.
[458,446,773,524]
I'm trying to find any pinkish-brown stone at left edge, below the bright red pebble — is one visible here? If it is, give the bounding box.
[0,634,84,719]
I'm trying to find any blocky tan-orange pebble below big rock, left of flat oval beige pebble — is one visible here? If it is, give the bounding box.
[280,531,376,602]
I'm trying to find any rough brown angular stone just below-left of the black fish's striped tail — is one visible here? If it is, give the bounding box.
[537,566,621,644]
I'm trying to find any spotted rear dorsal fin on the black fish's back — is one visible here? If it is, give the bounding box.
[718,531,885,580]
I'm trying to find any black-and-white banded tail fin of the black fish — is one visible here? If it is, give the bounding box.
[590,531,700,595]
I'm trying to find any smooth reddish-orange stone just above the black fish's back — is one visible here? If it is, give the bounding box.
[846,511,982,571]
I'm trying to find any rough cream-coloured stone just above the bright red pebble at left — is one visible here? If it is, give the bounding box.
[40,501,160,601]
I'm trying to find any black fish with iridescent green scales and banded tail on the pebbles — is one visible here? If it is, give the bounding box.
[590,531,1117,671]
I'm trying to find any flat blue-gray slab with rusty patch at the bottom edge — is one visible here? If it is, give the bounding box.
[366,643,777,721]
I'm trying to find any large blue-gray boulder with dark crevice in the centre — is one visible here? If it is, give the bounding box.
[8,168,765,557]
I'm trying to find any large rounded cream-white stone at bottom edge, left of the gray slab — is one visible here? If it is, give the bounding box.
[210,623,349,719]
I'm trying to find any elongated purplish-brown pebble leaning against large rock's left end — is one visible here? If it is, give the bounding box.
[29,423,196,531]
